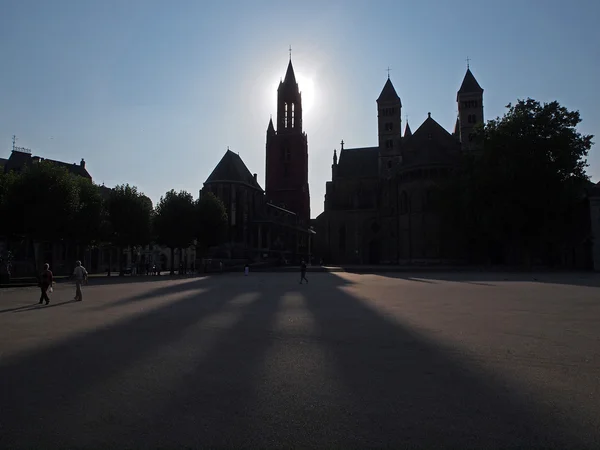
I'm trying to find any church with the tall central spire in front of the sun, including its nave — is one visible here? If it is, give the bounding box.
[200,59,314,261]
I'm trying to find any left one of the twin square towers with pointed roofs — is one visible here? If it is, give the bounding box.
[377,76,402,177]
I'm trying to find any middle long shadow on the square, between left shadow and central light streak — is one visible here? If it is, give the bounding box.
[131,288,284,448]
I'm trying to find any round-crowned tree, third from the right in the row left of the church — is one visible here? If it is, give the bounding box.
[107,184,153,273]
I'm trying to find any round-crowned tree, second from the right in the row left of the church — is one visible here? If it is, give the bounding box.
[154,190,196,275]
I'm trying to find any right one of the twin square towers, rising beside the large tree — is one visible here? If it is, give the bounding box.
[455,66,483,151]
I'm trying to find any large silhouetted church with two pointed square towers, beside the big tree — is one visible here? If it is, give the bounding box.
[315,69,484,264]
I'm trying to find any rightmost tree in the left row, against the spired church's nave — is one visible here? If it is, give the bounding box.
[196,192,227,251]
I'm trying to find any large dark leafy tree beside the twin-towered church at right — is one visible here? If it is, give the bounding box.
[454,99,593,262]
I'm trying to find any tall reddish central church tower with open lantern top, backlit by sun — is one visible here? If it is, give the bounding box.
[265,57,310,225]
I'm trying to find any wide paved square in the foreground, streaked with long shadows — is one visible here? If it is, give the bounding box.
[0,273,600,448]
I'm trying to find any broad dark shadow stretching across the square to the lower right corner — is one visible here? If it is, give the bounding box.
[306,275,585,448]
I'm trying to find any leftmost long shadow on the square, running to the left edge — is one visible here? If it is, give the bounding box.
[0,284,239,448]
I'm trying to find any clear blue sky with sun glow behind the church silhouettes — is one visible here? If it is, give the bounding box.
[0,0,600,217]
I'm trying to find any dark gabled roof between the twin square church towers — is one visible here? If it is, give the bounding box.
[402,116,460,166]
